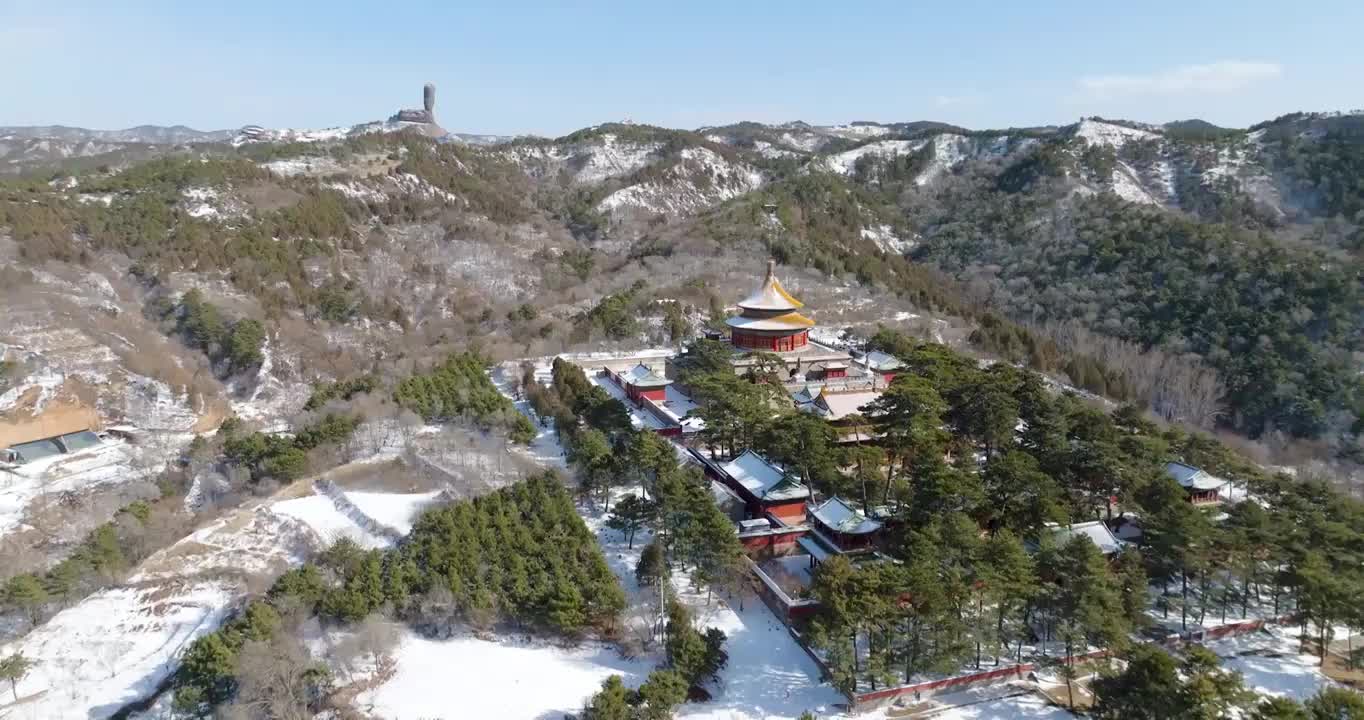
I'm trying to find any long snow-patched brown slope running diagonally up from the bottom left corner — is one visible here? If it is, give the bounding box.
[0,466,435,720]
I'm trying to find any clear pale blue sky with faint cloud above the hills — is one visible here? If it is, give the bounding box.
[0,0,1364,135]
